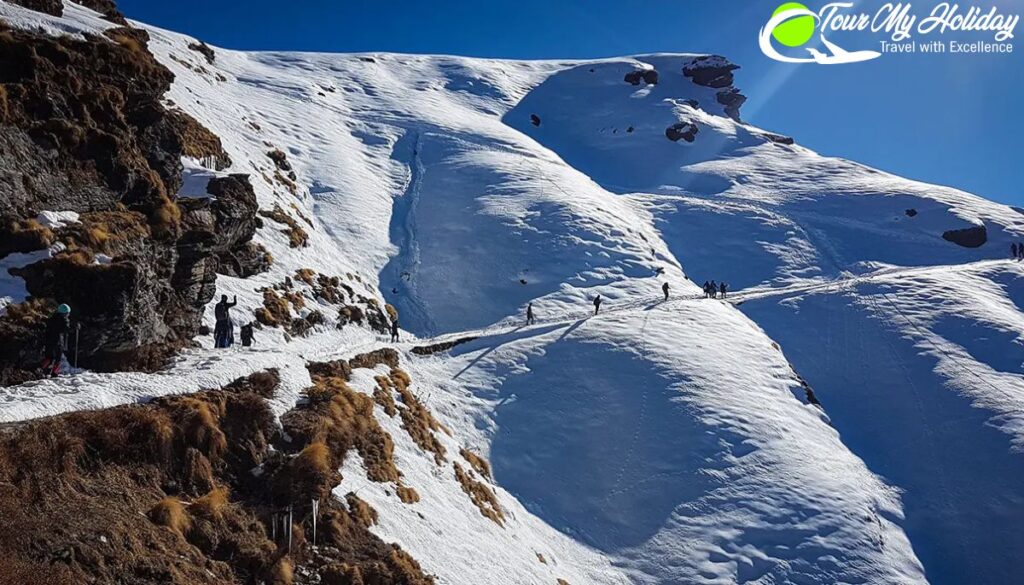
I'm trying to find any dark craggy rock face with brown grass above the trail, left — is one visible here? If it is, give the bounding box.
[0,20,256,384]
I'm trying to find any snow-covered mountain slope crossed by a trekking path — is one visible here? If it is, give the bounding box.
[0,4,1024,585]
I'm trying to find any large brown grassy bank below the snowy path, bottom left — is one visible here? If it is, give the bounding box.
[0,372,433,585]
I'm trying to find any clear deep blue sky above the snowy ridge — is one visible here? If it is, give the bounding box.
[119,0,1024,207]
